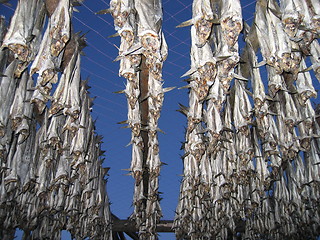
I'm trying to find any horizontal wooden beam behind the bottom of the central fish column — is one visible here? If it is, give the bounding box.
[112,219,174,233]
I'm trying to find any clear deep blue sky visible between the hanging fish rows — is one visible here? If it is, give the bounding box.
[0,0,262,239]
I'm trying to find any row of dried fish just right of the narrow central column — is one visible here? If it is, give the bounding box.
[174,0,242,239]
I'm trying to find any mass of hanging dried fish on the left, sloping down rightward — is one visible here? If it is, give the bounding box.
[0,0,111,239]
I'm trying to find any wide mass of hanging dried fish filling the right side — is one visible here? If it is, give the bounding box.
[174,0,320,239]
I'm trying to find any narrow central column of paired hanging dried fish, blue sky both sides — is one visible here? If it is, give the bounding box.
[100,0,171,239]
